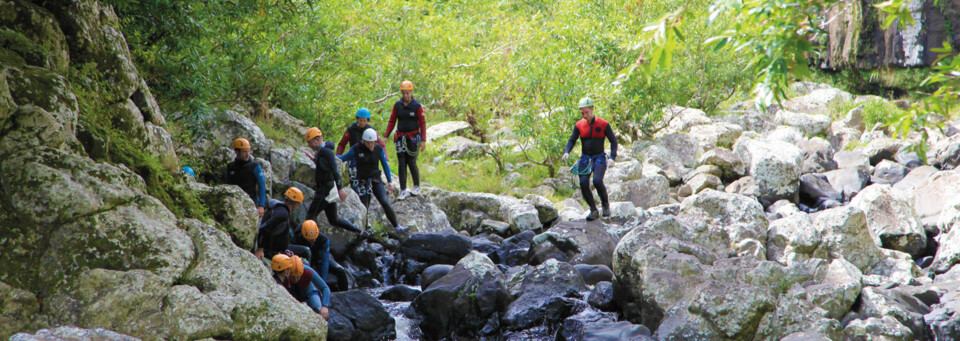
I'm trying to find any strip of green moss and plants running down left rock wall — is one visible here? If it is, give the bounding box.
[69,63,213,223]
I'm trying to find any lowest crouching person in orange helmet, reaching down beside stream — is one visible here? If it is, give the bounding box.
[270,253,330,320]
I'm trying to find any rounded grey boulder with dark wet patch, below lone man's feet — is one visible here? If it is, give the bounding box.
[529,220,617,266]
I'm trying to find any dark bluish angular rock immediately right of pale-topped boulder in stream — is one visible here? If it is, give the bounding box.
[503,259,586,330]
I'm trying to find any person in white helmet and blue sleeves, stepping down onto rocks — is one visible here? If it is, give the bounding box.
[337,129,407,233]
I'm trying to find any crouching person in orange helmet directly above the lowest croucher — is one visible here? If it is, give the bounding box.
[287,220,358,290]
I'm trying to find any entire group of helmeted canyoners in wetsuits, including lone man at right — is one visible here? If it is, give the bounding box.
[224,81,617,319]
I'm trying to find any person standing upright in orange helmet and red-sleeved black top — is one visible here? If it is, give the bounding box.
[384,81,427,200]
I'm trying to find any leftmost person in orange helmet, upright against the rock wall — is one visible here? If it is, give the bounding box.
[225,138,267,217]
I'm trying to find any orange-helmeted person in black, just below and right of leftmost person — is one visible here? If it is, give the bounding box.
[253,187,303,258]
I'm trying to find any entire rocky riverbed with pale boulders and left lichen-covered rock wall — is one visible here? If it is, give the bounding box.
[0,0,960,340]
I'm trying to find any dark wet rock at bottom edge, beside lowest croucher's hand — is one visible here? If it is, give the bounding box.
[328,290,396,340]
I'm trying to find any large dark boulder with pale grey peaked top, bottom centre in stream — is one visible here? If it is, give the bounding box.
[411,251,512,339]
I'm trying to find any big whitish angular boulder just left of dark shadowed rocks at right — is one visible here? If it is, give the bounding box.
[733,137,801,206]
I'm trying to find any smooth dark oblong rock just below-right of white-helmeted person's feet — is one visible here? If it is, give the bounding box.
[400,232,471,265]
